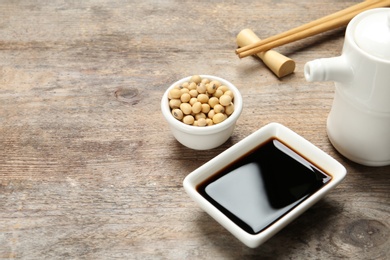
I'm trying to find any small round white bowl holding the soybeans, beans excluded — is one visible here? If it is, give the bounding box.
[161,75,242,150]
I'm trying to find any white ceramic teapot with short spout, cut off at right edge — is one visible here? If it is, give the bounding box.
[304,8,390,166]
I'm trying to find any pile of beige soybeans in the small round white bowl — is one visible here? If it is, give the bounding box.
[168,75,234,126]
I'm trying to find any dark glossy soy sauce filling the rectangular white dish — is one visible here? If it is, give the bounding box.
[197,138,331,234]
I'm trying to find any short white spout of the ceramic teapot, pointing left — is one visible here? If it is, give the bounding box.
[304,55,353,83]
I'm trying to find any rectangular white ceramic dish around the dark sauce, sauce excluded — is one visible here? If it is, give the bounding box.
[183,123,346,248]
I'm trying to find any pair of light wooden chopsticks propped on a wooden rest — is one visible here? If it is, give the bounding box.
[236,0,390,58]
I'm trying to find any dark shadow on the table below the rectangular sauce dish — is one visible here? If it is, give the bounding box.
[193,200,341,259]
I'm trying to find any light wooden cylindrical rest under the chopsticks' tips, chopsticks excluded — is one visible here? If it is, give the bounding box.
[237,29,295,78]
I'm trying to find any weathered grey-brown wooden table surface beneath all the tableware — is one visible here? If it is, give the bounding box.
[0,0,390,259]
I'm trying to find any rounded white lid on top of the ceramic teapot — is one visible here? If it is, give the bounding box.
[354,8,390,60]
